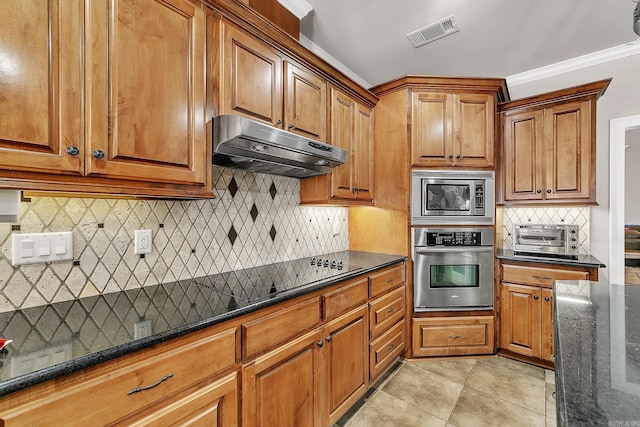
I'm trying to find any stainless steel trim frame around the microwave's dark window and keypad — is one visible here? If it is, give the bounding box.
[411,169,495,225]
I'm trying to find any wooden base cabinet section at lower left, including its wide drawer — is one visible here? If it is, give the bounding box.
[0,327,238,426]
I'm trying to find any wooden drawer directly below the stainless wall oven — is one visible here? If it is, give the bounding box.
[413,316,494,356]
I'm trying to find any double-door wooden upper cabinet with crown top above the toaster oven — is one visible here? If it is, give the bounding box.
[498,80,610,208]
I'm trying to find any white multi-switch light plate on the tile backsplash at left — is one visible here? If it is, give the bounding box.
[11,231,73,266]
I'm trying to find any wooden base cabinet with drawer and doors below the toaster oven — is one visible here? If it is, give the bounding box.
[499,261,598,367]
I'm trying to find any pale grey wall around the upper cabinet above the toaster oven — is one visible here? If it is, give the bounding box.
[509,54,640,279]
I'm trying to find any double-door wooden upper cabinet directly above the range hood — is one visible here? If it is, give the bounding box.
[216,18,327,141]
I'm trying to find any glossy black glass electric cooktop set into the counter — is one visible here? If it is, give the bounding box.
[192,254,361,307]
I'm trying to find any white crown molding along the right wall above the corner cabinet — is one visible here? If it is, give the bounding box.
[507,43,640,87]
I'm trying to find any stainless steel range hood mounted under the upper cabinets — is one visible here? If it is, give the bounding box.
[213,115,348,178]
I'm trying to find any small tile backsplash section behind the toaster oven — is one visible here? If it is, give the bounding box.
[502,207,591,254]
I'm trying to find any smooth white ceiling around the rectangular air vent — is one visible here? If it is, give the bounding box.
[300,0,638,86]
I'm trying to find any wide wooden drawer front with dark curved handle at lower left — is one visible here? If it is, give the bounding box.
[0,328,236,426]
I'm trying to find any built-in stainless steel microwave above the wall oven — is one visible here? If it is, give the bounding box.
[411,169,495,225]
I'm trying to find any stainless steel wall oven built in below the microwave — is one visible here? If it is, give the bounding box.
[413,228,493,312]
